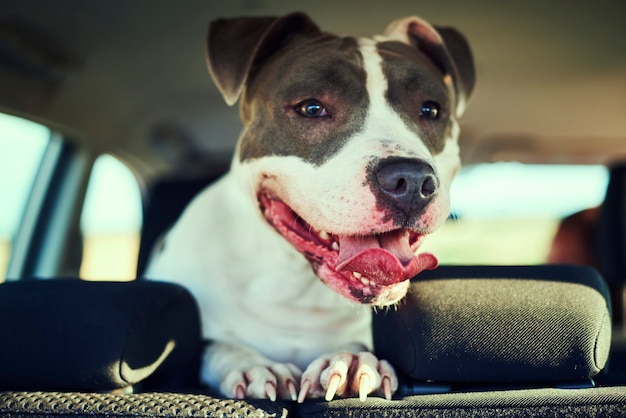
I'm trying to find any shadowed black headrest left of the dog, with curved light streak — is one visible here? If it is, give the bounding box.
[0,279,201,391]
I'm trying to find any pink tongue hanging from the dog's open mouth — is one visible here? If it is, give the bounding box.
[335,231,439,286]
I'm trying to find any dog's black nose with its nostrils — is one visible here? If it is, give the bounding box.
[375,159,438,216]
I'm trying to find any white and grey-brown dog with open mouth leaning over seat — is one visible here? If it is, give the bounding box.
[146,13,475,402]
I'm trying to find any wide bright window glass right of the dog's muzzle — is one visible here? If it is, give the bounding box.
[422,163,608,265]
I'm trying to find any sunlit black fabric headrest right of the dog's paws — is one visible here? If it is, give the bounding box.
[373,265,611,383]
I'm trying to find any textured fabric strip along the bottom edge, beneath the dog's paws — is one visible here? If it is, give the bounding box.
[0,387,626,418]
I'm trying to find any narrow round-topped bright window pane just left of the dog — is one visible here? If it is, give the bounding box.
[80,155,142,280]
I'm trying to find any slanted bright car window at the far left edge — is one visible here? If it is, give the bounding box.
[0,113,50,281]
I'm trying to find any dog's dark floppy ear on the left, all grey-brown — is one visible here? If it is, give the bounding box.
[207,13,320,106]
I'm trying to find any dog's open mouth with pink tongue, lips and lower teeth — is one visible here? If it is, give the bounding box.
[259,193,438,304]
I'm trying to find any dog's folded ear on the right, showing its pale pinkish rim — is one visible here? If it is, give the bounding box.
[385,17,476,116]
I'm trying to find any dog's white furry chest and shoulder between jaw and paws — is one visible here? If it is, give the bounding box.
[148,175,371,367]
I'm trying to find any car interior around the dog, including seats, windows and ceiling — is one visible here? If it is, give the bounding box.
[0,0,626,417]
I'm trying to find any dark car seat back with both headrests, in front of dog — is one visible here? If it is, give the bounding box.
[0,266,626,417]
